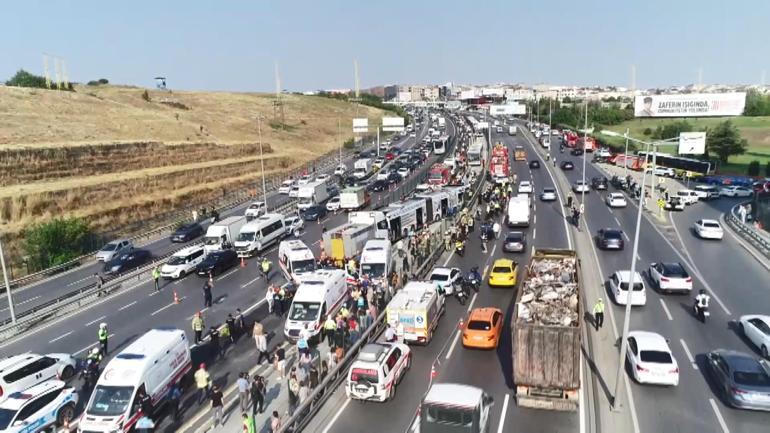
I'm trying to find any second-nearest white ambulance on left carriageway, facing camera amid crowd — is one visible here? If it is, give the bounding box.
[283,269,348,341]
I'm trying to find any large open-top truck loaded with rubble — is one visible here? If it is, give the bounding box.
[511,249,582,411]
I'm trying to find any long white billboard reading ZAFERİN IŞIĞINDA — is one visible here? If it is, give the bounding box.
[634,92,746,117]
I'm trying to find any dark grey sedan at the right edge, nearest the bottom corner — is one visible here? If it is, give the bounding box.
[706,349,770,411]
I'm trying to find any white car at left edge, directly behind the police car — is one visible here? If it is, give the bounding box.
[0,352,77,402]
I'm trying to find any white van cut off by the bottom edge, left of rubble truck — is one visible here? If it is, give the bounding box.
[416,383,494,433]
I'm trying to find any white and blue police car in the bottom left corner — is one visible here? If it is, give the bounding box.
[0,380,78,433]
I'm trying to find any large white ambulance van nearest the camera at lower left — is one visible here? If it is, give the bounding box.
[78,328,192,433]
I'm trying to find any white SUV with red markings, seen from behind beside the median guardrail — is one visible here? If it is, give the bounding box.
[345,343,412,402]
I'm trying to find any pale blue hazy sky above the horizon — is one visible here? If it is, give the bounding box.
[0,0,770,91]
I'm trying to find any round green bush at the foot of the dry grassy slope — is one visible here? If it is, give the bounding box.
[24,218,93,269]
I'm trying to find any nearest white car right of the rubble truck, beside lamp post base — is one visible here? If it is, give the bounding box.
[626,331,679,386]
